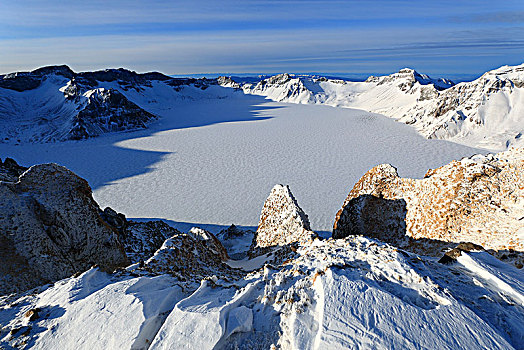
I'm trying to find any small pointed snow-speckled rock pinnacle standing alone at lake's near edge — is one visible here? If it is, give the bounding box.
[253,185,316,248]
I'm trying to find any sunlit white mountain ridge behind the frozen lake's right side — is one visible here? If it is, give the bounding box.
[235,64,524,150]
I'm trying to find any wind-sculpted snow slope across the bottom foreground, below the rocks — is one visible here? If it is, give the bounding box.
[0,237,524,349]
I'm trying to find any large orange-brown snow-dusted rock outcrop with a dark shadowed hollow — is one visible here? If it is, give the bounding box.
[333,149,524,260]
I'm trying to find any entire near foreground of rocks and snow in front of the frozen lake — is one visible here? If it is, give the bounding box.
[0,149,524,349]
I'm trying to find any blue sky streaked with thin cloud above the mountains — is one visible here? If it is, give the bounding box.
[0,0,524,77]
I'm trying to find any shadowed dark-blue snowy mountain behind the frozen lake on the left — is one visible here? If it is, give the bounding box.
[0,66,219,143]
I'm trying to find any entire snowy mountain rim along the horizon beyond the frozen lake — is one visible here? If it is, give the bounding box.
[0,64,524,150]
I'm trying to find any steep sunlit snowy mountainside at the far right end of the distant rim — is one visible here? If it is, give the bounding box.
[398,64,524,150]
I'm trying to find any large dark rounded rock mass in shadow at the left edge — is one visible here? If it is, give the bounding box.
[0,164,128,294]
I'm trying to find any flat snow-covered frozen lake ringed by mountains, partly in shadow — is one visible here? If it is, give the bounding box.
[0,92,487,231]
